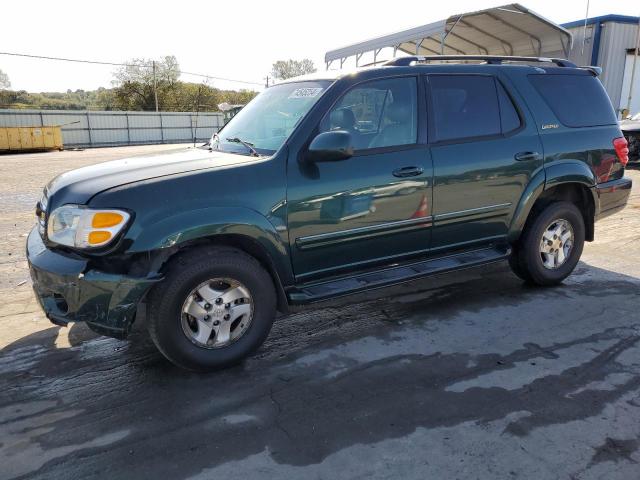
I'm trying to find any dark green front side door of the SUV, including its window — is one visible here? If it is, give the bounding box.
[287,76,432,281]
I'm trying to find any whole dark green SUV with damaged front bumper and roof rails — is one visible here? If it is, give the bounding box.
[27,56,631,370]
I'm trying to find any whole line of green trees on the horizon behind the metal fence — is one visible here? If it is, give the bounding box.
[0,55,316,112]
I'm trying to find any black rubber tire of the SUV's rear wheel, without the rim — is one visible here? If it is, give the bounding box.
[509,202,585,286]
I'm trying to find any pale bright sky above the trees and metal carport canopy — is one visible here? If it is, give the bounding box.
[0,0,640,92]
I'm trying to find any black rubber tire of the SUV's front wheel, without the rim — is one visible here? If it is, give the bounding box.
[147,247,276,371]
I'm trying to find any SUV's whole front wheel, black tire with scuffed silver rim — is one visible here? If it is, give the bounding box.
[147,248,276,371]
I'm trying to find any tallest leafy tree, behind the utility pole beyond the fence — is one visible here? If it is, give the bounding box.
[114,55,180,110]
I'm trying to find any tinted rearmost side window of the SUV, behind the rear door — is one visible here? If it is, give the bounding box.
[529,74,617,127]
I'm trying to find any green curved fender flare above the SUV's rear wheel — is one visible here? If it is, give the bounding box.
[507,160,597,243]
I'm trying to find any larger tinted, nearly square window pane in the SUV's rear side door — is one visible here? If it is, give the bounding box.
[429,75,502,141]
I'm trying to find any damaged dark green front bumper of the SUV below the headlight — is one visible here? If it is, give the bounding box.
[27,228,161,338]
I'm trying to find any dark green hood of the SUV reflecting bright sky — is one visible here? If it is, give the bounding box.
[46,148,264,207]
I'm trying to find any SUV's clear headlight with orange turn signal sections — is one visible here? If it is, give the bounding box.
[47,205,131,248]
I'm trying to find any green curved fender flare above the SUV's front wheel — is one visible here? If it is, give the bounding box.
[127,207,293,285]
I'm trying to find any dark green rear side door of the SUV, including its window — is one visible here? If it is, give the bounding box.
[427,74,543,252]
